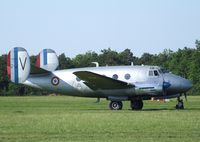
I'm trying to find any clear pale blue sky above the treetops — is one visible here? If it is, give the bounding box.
[0,0,200,58]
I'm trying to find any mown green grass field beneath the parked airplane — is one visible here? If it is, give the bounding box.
[0,96,200,142]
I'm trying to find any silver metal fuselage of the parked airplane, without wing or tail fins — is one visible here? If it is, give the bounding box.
[24,66,192,98]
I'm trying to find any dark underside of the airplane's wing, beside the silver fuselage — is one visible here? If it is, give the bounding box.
[73,71,135,90]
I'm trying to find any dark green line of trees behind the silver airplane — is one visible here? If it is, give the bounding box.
[0,40,200,96]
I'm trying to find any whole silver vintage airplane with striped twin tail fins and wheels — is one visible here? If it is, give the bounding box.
[7,47,192,110]
